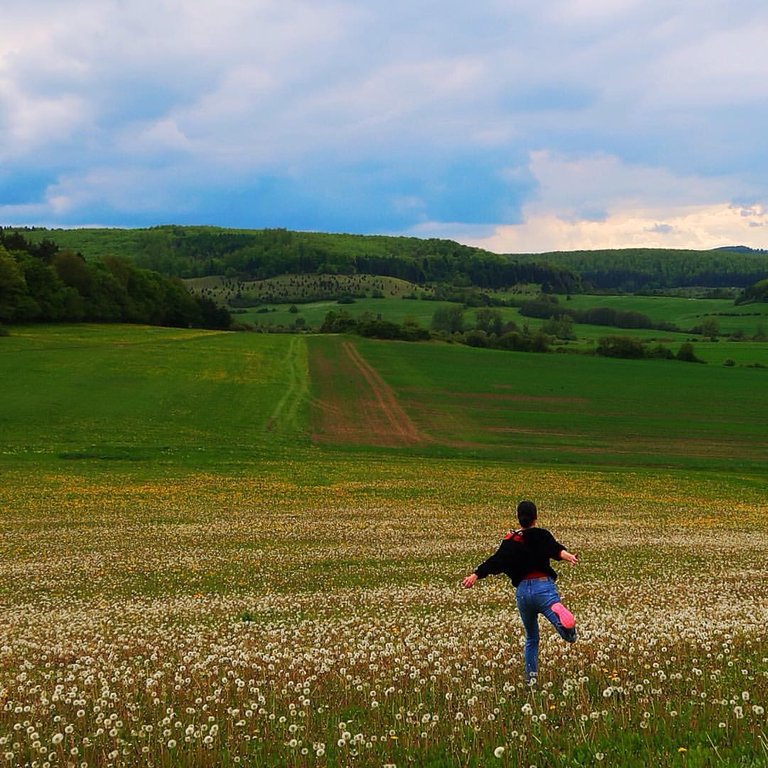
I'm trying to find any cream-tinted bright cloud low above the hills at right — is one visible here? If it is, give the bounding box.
[444,152,768,253]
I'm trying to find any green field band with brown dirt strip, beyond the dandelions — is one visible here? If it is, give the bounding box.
[0,324,768,468]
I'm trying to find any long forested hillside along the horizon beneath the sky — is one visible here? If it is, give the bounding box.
[6,226,768,293]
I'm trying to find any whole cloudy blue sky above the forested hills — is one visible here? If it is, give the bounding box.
[0,0,768,253]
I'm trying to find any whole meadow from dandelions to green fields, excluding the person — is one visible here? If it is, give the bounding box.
[0,326,768,768]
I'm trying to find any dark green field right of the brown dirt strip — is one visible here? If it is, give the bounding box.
[346,341,768,467]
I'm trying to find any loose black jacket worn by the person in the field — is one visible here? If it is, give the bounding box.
[475,526,565,586]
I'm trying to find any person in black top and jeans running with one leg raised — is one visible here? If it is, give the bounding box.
[462,501,578,682]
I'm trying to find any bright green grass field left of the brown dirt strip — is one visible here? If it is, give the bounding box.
[0,325,307,459]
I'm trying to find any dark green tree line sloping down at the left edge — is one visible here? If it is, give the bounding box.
[0,229,231,329]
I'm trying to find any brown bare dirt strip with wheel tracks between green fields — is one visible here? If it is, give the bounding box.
[311,341,427,446]
